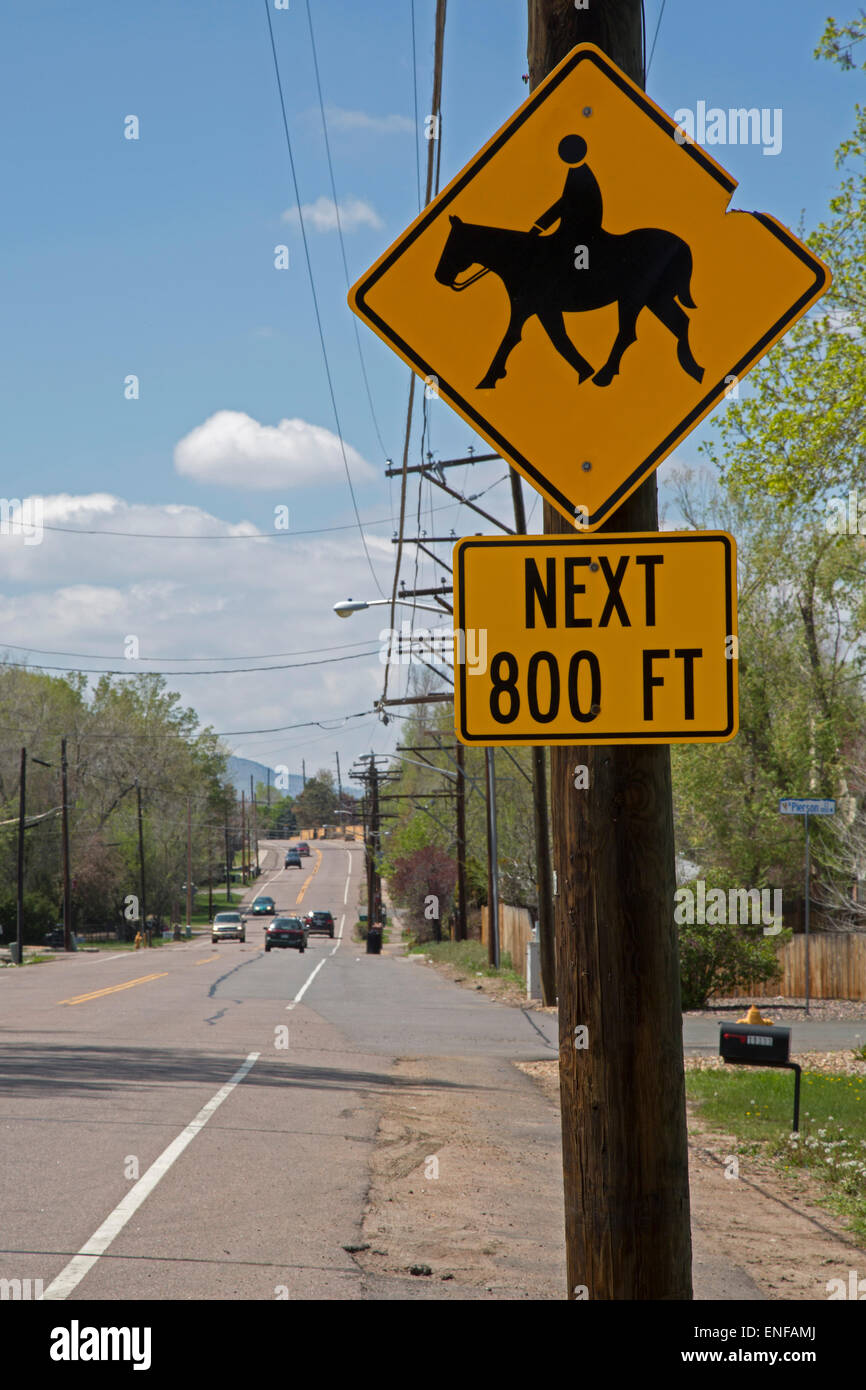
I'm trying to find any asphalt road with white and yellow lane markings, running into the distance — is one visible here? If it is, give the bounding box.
[0,841,556,1301]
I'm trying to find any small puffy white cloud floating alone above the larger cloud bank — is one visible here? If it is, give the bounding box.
[174,410,375,489]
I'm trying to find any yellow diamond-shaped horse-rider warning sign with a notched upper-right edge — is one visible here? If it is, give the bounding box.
[349,44,830,531]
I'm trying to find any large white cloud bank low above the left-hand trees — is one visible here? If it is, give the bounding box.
[0,493,393,771]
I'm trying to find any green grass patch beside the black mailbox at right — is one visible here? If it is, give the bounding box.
[685,1068,866,1237]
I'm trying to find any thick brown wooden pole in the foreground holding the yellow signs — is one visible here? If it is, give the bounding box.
[528,0,692,1300]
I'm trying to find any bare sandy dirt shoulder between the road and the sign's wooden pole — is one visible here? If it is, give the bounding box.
[354,1056,566,1300]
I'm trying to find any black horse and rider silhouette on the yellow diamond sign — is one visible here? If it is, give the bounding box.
[435,135,703,391]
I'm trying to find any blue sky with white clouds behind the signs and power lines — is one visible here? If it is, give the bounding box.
[0,0,863,770]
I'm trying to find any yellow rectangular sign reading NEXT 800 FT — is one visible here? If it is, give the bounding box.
[455,531,738,744]
